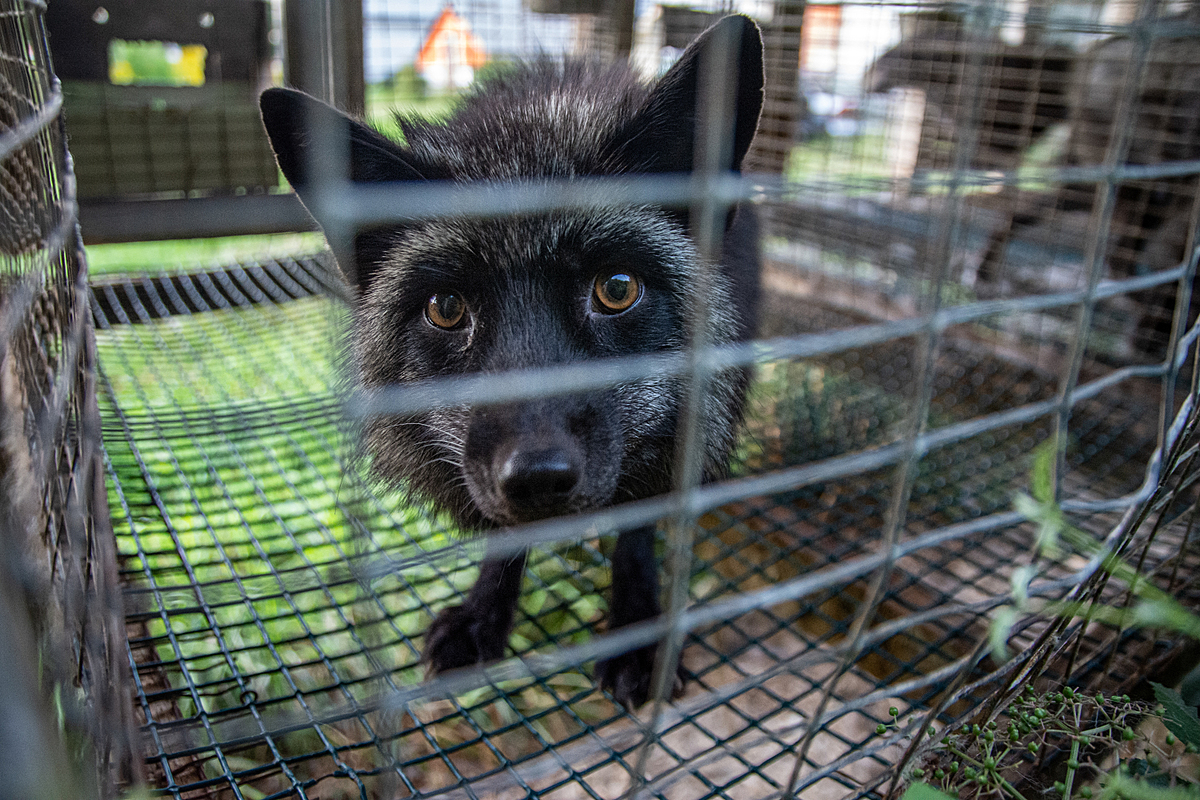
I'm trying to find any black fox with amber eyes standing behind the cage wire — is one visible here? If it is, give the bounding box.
[260,16,763,705]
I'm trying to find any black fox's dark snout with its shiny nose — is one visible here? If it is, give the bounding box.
[462,397,622,524]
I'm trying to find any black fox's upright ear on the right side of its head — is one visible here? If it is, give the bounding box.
[613,14,763,173]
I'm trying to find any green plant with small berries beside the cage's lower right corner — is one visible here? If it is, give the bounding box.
[902,434,1200,800]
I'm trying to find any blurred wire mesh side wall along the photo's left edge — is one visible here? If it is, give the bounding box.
[0,0,137,798]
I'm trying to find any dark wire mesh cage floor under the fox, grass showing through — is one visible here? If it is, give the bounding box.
[92,257,1176,800]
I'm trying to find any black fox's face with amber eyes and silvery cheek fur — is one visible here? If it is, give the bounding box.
[355,210,737,527]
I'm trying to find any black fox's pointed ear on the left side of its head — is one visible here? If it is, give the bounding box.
[258,89,443,291]
